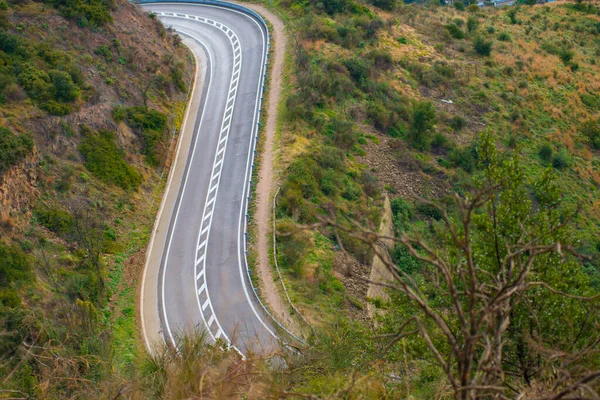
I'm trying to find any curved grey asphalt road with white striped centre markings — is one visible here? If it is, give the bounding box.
[142,3,276,354]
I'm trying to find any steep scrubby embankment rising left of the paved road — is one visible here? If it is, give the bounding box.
[0,1,193,397]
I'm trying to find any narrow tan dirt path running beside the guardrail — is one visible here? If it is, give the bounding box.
[234,3,298,332]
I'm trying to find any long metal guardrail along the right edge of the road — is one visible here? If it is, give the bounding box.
[134,0,306,344]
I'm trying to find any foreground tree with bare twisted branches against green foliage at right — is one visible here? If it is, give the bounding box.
[294,136,600,400]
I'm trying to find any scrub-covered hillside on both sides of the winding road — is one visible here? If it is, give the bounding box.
[0,0,600,399]
